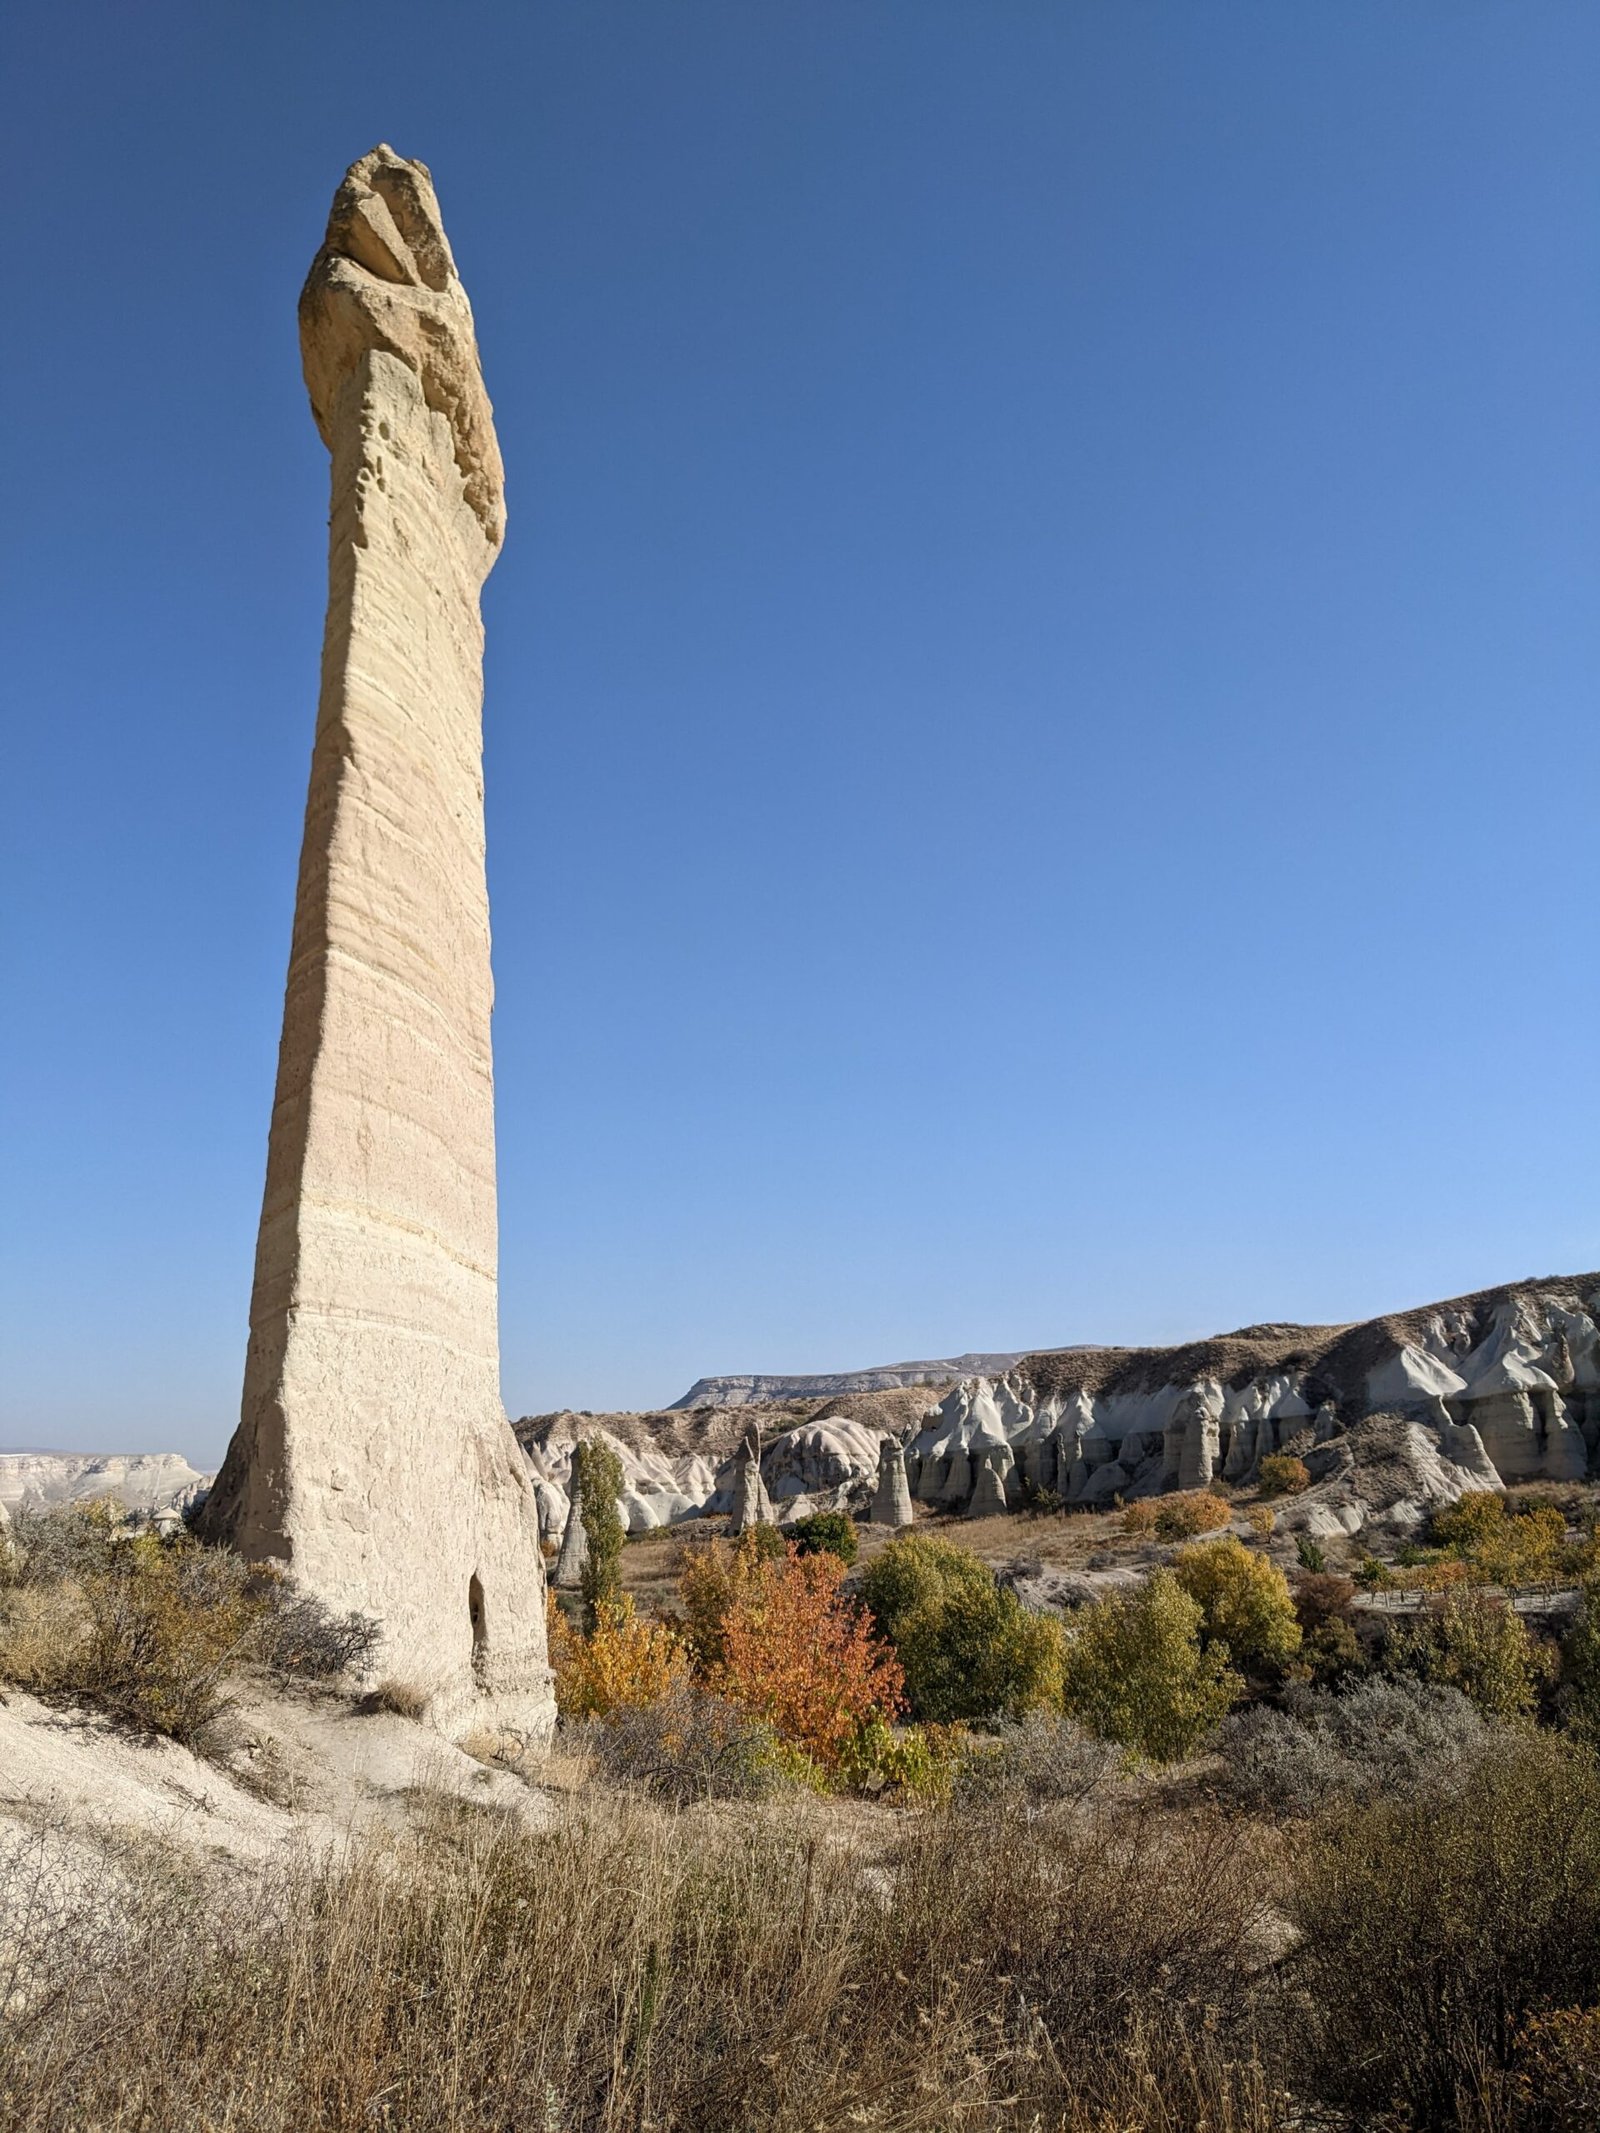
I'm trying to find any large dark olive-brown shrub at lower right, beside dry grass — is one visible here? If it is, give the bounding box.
[1284,1732,1600,2133]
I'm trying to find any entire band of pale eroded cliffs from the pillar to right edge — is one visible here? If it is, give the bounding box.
[546,1273,1600,1534]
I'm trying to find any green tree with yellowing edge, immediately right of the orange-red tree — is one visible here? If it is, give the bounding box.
[862,1534,1062,1726]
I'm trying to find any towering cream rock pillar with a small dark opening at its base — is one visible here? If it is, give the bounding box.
[205,147,553,1741]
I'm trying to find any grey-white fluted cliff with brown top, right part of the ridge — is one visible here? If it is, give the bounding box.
[907,1273,1600,1529]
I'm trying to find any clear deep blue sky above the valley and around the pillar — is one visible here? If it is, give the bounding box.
[0,0,1600,1461]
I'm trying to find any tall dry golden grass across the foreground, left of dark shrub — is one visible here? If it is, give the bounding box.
[0,1796,1286,2133]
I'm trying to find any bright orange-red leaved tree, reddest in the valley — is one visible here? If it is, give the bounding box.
[699,1549,905,1770]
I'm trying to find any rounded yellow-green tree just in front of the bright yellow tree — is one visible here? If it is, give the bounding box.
[1062,1570,1244,1762]
